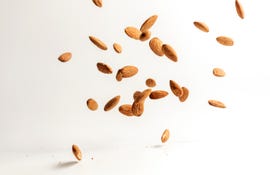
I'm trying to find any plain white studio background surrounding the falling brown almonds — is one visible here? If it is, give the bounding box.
[0,0,270,175]
